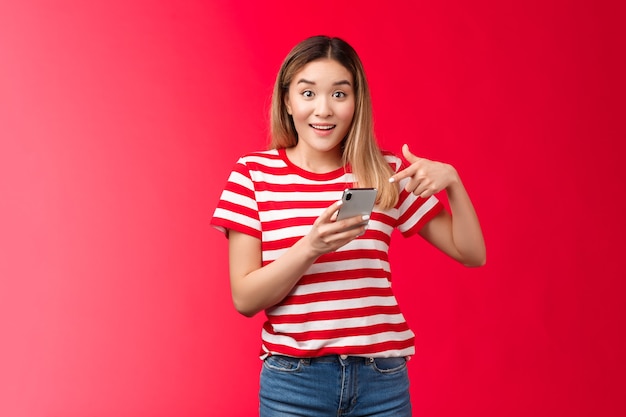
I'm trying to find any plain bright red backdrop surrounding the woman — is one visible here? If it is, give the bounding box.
[0,0,626,417]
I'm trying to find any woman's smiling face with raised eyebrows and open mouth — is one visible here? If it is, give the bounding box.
[285,59,355,153]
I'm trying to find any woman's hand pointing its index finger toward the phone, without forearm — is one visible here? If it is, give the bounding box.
[389,144,459,198]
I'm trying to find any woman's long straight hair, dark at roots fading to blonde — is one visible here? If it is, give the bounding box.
[270,36,398,209]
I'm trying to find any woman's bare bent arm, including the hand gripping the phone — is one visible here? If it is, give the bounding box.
[228,202,365,317]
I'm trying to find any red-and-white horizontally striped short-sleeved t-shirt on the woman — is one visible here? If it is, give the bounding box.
[211,149,443,358]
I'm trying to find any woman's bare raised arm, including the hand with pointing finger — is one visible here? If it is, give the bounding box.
[390,145,486,267]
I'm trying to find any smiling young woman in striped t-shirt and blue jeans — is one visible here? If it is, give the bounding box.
[212,36,485,417]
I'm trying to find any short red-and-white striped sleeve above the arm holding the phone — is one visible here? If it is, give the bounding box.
[211,158,261,239]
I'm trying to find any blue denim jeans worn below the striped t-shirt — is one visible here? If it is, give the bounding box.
[259,356,411,417]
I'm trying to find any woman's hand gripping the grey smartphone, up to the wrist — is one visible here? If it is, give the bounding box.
[303,200,369,256]
